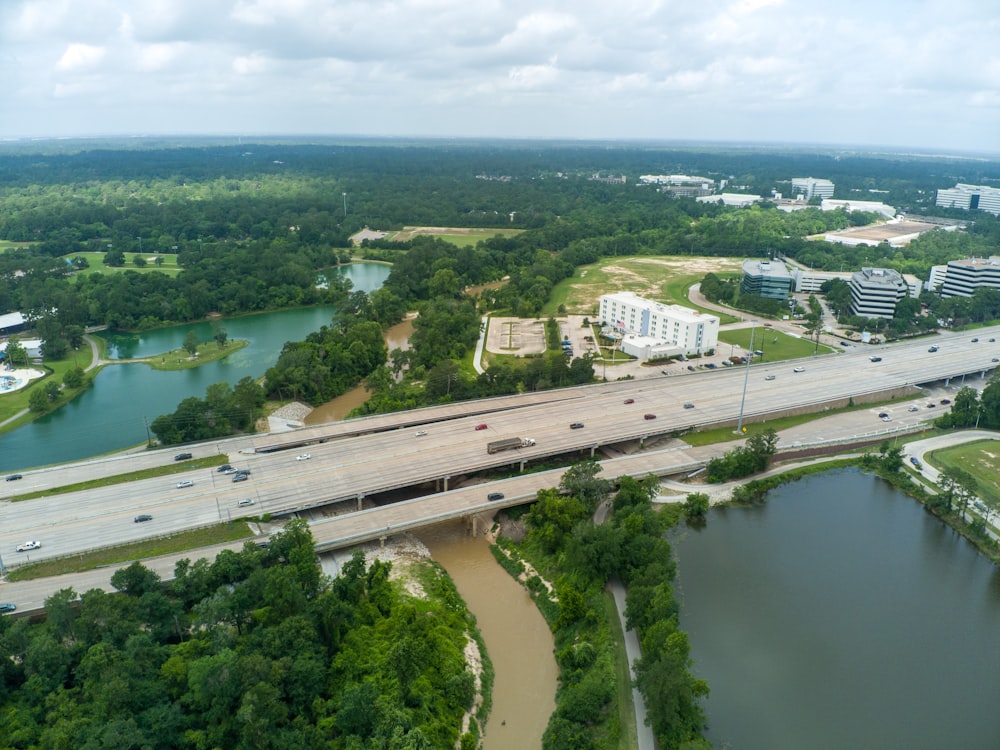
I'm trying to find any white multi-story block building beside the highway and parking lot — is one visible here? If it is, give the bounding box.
[600,292,719,359]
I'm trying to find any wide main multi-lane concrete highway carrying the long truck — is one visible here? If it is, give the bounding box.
[0,327,1000,566]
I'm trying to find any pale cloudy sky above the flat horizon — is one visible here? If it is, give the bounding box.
[0,0,1000,152]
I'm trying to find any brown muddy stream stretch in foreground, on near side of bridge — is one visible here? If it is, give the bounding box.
[417,522,558,750]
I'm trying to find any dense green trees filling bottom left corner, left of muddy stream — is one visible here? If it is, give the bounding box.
[0,521,489,750]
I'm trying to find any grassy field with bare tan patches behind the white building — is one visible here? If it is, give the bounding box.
[541,255,741,323]
